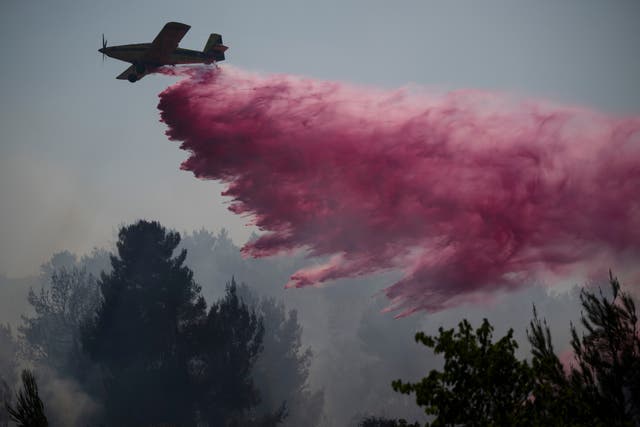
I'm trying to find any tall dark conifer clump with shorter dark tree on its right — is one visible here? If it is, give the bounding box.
[82,221,270,426]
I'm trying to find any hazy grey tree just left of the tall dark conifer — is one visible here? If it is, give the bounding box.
[19,267,100,379]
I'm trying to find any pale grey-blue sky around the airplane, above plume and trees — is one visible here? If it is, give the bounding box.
[0,0,640,276]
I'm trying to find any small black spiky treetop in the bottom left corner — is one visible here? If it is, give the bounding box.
[5,369,49,427]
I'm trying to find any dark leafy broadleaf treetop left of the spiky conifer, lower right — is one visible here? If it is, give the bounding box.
[392,319,532,426]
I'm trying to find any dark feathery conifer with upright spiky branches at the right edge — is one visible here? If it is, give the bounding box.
[528,272,640,426]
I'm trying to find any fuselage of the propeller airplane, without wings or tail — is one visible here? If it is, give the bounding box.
[99,43,213,67]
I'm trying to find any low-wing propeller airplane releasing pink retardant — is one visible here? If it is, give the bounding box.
[98,22,228,83]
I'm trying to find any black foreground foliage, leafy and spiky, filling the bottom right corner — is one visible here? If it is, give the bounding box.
[392,274,640,426]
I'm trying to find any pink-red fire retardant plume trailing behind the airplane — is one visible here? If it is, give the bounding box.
[158,68,640,315]
